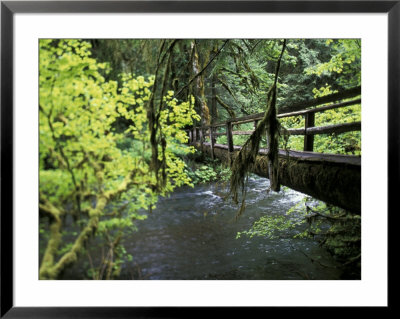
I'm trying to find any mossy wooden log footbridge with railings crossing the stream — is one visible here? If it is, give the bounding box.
[188,87,361,214]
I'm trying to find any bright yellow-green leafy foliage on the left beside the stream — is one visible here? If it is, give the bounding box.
[39,40,198,278]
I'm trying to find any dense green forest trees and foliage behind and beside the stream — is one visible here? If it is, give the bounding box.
[39,39,361,279]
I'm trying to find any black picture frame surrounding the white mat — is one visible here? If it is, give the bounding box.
[0,0,394,318]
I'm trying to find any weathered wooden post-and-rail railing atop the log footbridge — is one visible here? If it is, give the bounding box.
[188,87,361,158]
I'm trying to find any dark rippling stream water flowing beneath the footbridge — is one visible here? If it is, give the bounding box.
[63,176,341,280]
